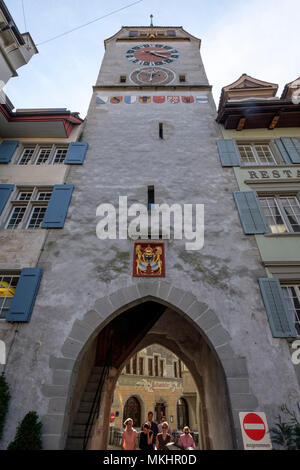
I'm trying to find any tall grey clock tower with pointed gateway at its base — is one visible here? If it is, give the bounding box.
[25,26,284,449]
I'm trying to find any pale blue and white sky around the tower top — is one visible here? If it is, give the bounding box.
[4,0,300,118]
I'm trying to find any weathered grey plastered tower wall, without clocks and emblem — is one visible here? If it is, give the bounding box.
[1,23,299,449]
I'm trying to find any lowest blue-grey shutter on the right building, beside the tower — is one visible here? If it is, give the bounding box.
[258,277,297,338]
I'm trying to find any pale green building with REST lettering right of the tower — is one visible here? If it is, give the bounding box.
[217,74,300,390]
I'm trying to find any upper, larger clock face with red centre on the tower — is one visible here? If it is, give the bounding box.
[126,44,179,66]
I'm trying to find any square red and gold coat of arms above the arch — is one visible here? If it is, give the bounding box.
[133,243,165,277]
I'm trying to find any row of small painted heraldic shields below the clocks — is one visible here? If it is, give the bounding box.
[96,95,208,104]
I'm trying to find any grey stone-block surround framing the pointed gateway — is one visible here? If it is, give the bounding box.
[42,280,257,449]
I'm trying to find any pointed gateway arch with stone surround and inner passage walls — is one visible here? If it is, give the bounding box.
[43,280,257,450]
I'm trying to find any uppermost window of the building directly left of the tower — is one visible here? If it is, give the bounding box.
[17,145,68,166]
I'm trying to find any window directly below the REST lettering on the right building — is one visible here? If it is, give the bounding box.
[260,196,300,233]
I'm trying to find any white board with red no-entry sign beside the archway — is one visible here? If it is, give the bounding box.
[239,412,272,450]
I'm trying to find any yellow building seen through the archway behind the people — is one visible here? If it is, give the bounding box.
[111,345,198,432]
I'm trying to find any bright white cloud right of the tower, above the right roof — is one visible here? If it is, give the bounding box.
[202,0,300,103]
